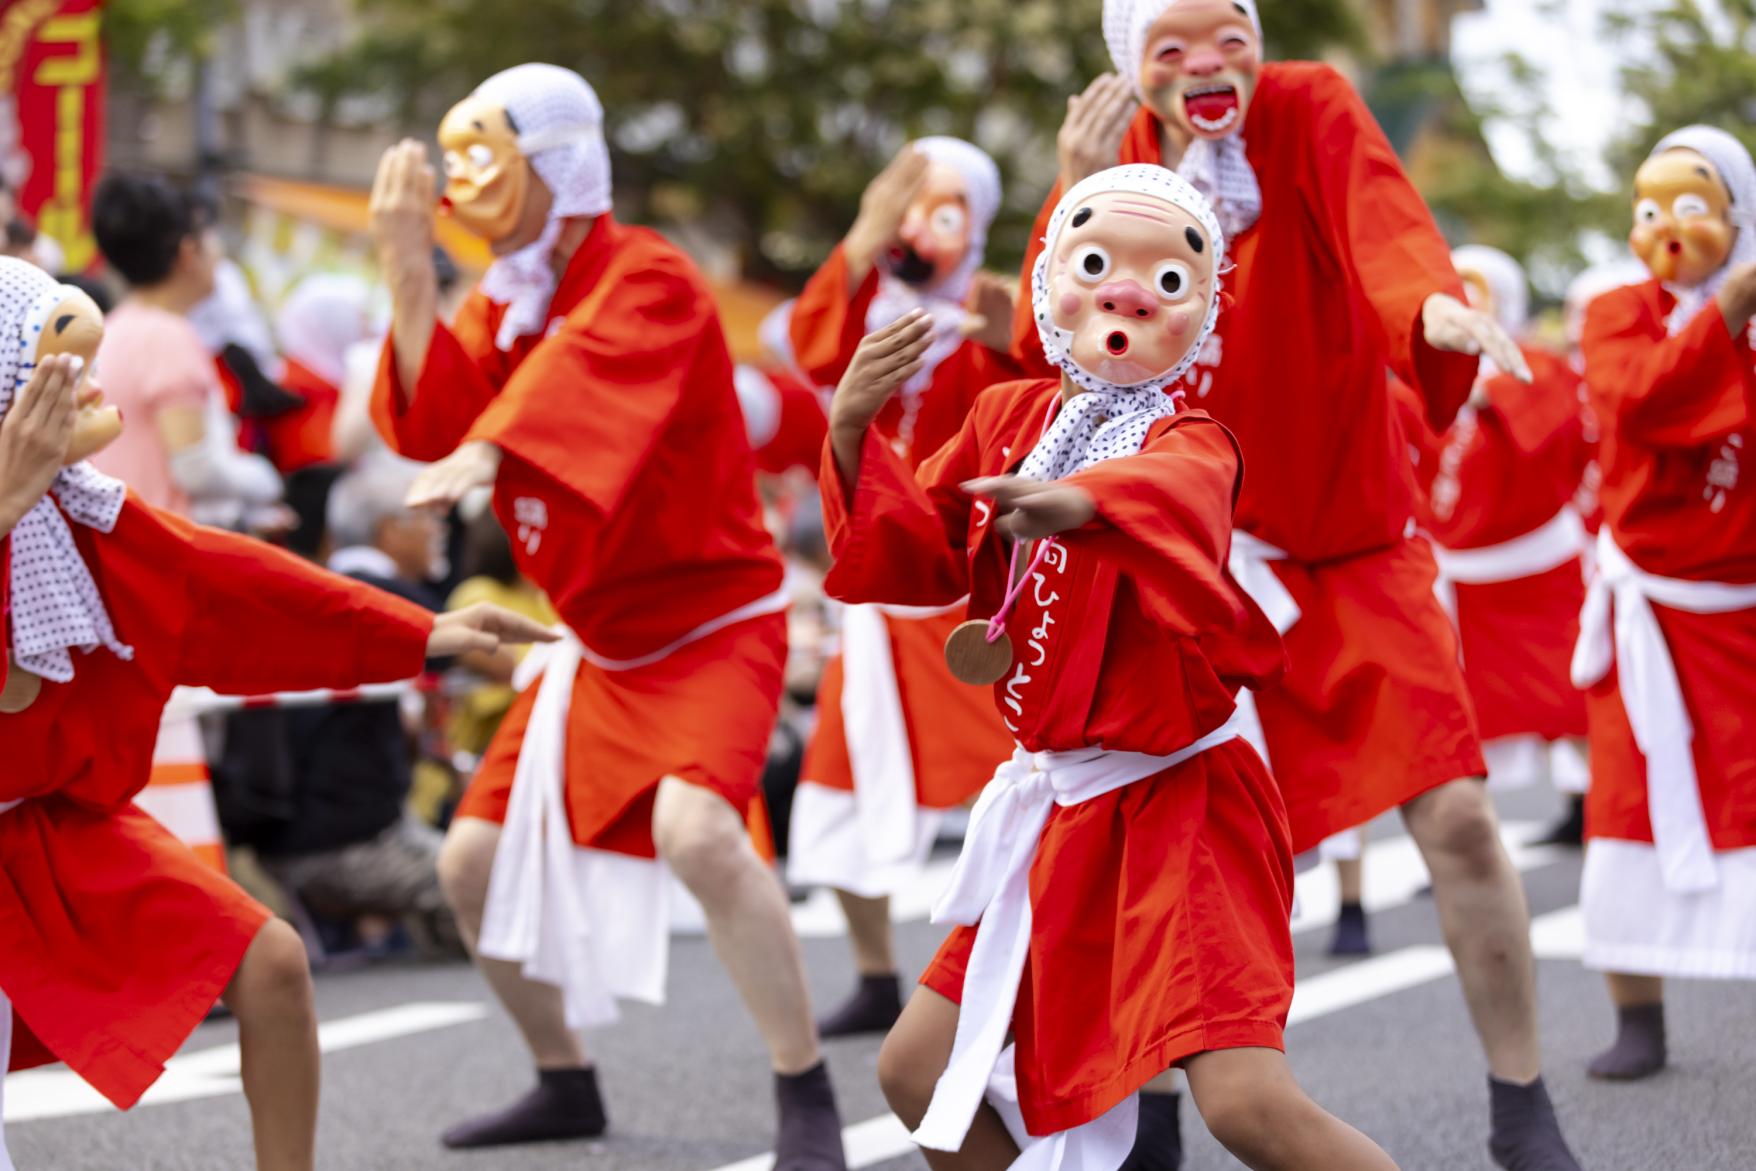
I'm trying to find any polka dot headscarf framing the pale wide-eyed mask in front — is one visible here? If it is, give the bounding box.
[1018,163,1226,481]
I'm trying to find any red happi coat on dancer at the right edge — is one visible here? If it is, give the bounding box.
[1582,281,1756,850]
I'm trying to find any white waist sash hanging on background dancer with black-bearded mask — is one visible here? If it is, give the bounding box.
[841,600,964,866]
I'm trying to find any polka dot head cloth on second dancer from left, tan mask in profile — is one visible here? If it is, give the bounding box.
[476,65,611,349]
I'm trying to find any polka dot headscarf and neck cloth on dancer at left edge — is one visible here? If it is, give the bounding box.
[0,258,133,683]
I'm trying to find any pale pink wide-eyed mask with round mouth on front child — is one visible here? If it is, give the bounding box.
[1038,172,1219,386]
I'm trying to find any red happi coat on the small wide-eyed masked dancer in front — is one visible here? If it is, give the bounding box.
[820,379,1292,1134]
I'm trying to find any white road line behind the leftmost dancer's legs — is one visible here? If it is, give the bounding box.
[5,1001,488,1124]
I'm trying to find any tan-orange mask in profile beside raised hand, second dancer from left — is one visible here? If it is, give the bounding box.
[439,95,550,253]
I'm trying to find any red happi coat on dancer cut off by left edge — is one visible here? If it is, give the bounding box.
[0,499,434,1108]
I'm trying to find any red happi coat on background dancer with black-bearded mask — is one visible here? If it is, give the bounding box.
[790,244,1020,809]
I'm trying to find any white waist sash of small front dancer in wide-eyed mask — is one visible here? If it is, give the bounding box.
[915,713,1241,1171]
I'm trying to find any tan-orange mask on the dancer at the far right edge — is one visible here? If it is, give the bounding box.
[1628,149,1738,288]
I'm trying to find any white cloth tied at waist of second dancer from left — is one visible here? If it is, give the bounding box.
[478,590,787,1029]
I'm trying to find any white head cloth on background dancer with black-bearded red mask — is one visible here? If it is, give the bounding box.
[866,135,1001,405]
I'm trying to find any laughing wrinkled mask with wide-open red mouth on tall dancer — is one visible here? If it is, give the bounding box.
[1136,0,1263,139]
